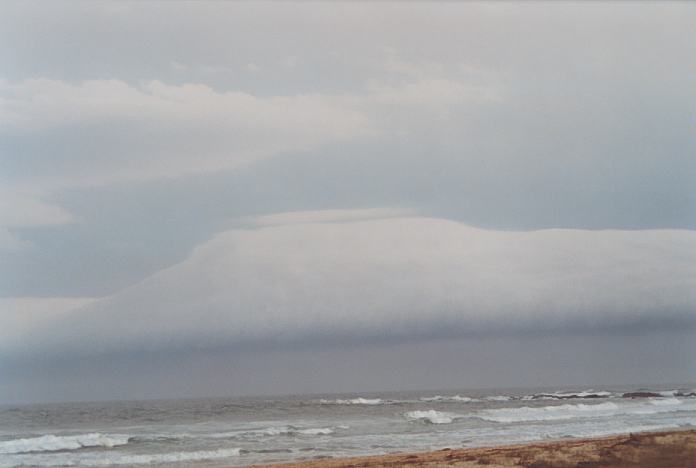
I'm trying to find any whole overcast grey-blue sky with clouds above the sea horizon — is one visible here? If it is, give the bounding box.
[0,1,696,403]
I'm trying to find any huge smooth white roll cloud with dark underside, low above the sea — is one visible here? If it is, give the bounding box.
[2,213,696,355]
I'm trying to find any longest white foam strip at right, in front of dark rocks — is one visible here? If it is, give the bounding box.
[478,402,619,423]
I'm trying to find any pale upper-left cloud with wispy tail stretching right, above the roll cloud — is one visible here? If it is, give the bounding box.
[0,72,494,248]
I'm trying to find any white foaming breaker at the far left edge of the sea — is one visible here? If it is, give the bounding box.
[0,433,130,454]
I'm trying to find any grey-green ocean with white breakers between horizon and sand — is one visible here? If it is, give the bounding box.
[0,386,696,467]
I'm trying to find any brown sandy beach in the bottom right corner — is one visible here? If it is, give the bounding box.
[249,430,696,468]
